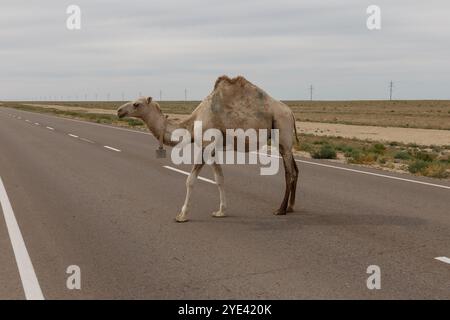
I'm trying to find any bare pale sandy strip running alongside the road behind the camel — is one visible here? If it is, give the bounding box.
[24,104,450,146]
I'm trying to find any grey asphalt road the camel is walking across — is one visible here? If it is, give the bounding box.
[0,108,450,299]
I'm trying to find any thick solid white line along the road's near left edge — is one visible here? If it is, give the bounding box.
[0,177,44,300]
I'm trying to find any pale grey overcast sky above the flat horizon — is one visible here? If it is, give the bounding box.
[0,0,450,100]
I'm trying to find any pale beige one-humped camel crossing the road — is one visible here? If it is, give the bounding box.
[117,76,298,222]
